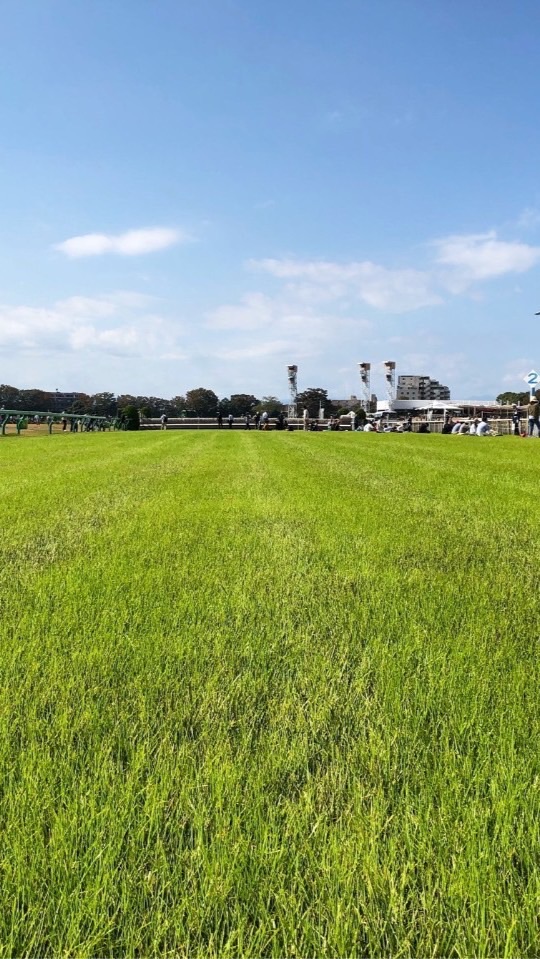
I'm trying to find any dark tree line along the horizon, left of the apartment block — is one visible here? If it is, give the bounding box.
[0,384,363,418]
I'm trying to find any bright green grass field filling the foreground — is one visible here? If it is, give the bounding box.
[0,431,540,957]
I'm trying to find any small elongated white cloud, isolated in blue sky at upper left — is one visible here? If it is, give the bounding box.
[54,226,190,259]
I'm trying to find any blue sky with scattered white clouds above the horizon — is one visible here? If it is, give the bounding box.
[0,0,540,399]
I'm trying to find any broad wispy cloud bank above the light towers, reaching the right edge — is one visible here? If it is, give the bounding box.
[200,222,540,395]
